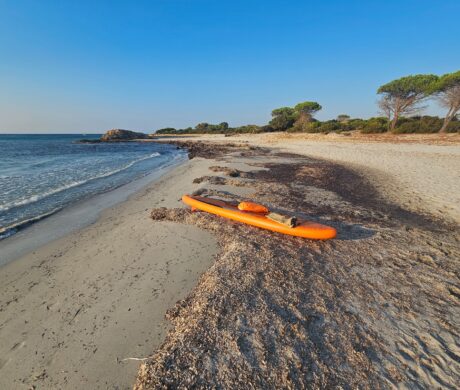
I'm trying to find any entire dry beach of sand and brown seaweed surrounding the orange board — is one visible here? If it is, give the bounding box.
[0,135,460,389]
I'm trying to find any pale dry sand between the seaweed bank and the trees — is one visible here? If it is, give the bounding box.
[155,133,460,223]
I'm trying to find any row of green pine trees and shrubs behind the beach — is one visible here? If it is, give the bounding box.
[157,71,460,135]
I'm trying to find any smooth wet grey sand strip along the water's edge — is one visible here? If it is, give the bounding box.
[0,151,187,268]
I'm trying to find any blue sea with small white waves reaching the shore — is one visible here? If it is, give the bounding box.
[0,134,186,240]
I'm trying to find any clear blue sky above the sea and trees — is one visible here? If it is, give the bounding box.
[0,0,460,133]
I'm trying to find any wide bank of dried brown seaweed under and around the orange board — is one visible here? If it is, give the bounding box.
[135,145,460,390]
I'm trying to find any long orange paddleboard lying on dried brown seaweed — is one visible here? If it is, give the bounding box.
[182,195,337,240]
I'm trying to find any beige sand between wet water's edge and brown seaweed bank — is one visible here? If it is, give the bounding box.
[0,161,217,389]
